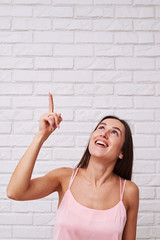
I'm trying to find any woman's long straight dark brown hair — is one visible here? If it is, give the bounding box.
[76,116,133,180]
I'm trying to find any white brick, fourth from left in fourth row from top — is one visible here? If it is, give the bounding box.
[114,32,154,44]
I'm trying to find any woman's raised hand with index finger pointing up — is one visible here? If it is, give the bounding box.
[38,93,62,141]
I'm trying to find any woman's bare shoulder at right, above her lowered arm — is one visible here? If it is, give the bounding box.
[125,180,139,207]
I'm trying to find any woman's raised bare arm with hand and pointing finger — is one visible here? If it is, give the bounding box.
[7,93,62,200]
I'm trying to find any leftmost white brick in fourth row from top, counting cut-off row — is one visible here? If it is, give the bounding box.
[0,32,32,43]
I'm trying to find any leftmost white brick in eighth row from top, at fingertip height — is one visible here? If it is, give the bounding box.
[0,84,32,95]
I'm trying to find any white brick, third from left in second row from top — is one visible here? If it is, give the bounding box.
[75,6,114,17]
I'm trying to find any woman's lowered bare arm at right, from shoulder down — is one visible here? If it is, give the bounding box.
[122,181,139,240]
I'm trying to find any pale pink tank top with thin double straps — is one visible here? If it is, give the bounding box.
[54,168,126,240]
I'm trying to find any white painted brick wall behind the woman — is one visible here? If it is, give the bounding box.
[0,0,160,240]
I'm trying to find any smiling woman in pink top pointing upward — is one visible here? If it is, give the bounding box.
[7,94,139,240]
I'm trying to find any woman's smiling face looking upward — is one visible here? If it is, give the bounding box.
[89,118,125,162]
